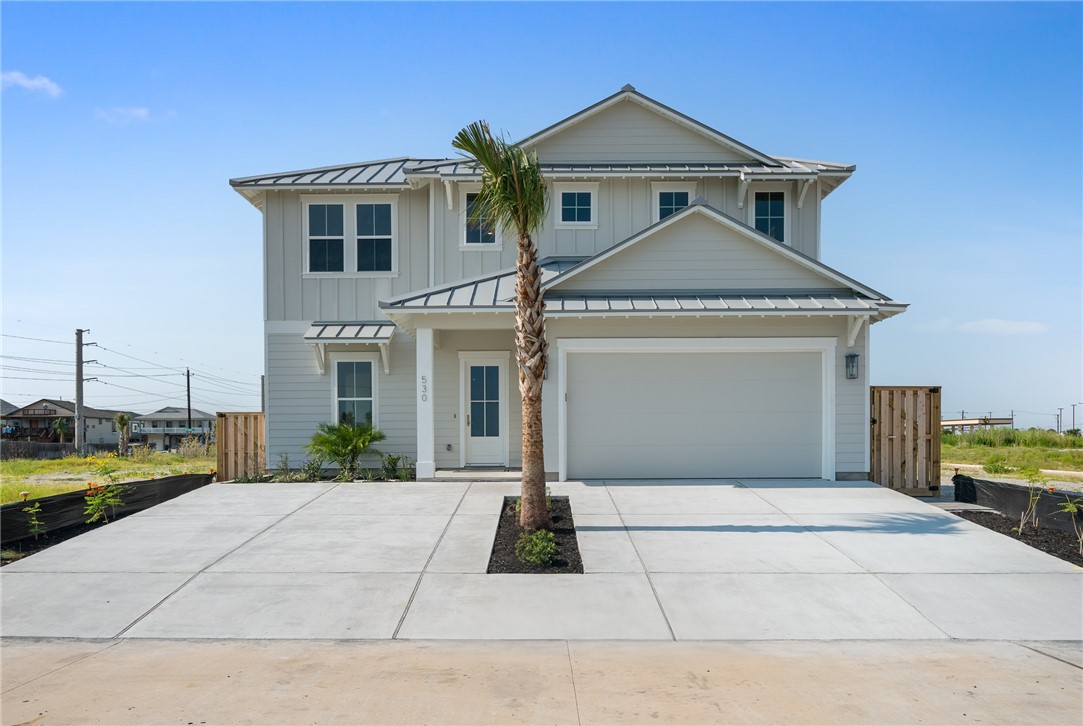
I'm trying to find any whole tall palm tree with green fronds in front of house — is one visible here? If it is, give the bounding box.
[452,121,552,530]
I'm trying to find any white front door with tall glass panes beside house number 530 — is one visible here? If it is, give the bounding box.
[462,353,508,466]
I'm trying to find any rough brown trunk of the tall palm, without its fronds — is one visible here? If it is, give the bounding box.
[516,235,552,530]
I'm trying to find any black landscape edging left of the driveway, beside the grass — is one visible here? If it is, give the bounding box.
[0,474,214,545]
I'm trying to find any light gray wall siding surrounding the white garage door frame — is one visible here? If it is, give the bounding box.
[542,317,869,478]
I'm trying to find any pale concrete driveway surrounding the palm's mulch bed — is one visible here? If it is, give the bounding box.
[0,480,1083,640]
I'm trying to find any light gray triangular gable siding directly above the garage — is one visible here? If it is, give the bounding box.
[554,215,838,290]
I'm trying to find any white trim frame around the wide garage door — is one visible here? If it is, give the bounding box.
[557,338,837,481]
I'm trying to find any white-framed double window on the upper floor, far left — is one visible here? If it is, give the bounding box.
[302,195,397,276]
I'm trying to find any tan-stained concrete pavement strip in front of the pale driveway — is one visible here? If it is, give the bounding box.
[2,639,1083,725]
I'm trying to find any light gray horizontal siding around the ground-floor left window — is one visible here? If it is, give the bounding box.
[265,333,417,467]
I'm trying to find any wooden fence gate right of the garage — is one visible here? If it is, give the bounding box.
[870,386,940,496]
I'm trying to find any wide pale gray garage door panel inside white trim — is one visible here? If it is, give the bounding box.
[565,352,823,479]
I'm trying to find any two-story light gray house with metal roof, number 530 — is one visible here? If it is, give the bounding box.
[231,86,905,479]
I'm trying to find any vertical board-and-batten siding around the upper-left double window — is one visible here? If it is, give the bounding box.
[263,189,429,321]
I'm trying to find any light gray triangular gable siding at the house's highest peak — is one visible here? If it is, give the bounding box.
[536,101,748,161]
